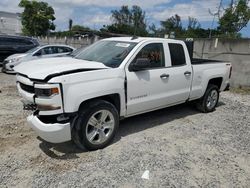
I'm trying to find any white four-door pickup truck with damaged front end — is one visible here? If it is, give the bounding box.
[15,37,232,150]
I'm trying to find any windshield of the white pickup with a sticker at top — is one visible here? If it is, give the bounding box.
[75,41,137,67]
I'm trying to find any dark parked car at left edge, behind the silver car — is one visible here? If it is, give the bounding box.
[0,35,39,65]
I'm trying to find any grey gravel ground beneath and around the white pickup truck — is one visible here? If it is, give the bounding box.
[0,73,250,188]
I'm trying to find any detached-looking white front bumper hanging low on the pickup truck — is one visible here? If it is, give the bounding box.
[27,115,71,143]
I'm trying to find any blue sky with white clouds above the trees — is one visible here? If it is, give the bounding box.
[0,0,250,38]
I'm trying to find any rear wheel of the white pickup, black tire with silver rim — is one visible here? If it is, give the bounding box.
[196,84,219,113]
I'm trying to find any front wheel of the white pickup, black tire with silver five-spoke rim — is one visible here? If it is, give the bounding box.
[72,100,119,150]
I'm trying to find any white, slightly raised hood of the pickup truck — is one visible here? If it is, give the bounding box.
[14,57,109,80]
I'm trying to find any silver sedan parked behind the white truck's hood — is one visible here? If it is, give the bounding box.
[2,44,75,73]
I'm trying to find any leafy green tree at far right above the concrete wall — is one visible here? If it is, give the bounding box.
[218,0,250,37]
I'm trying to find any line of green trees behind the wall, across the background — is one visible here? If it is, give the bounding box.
[19,0,250,38]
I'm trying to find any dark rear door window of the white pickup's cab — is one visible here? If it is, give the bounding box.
[168,43,186,66]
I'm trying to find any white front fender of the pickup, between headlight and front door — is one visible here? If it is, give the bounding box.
[52,70,126,115]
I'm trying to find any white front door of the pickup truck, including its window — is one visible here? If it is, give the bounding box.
[126,42,168,116]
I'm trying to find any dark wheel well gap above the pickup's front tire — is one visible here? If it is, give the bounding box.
[79,93,121,114]
